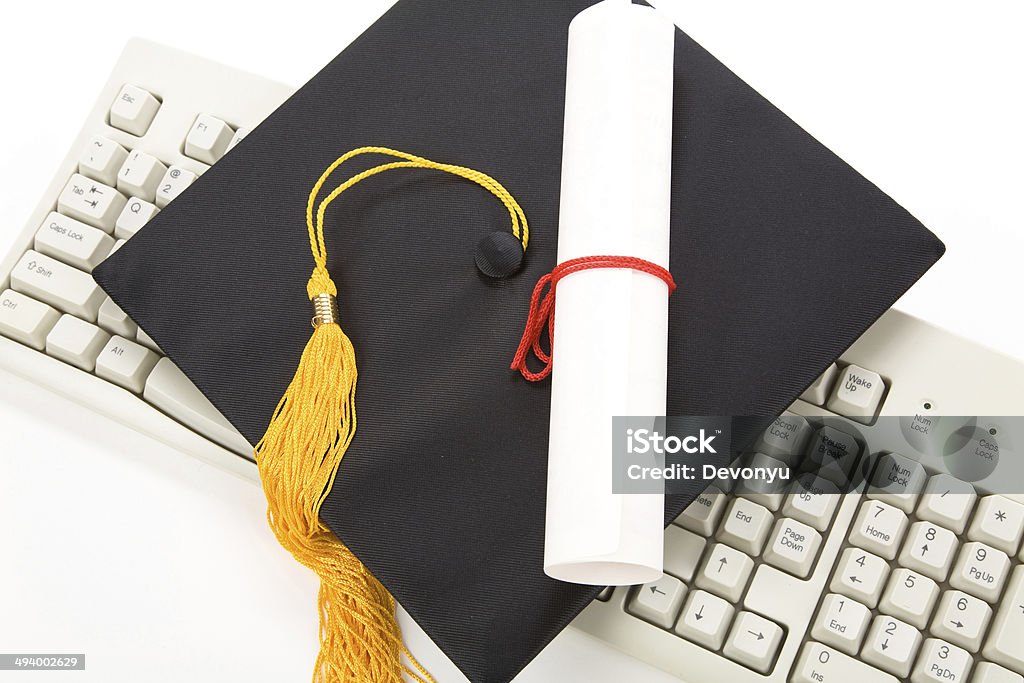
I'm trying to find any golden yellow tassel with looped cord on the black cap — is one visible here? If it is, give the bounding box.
[255,147,528,683]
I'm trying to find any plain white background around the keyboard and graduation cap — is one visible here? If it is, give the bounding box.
[0,0,1024,683]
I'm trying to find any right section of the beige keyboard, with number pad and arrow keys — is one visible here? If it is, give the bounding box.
[573,327,1024,683]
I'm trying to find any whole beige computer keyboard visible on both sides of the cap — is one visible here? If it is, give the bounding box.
[0,40,1024,683]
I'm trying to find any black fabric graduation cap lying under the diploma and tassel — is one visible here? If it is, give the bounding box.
[93,0,943,683]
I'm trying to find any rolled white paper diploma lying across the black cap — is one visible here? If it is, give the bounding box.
[544,0,675,586]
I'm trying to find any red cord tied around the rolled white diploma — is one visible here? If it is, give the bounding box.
[511,256,676,382]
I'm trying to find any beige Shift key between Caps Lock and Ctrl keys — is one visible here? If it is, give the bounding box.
[10,249,106,323]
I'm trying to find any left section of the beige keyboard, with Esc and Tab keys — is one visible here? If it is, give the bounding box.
[0,40,293,478]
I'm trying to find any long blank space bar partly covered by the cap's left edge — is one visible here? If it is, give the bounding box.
[142,358,251,454]
